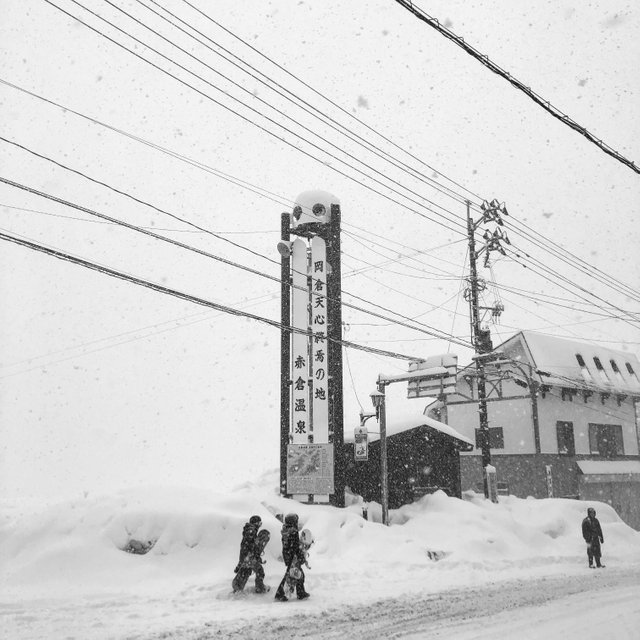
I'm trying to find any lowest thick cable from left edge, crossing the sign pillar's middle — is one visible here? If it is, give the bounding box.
[0,232,418,360]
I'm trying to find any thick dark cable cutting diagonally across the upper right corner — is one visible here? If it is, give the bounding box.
[396,0,640,173]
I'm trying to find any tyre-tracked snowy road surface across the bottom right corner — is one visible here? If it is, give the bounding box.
[148,567,640,640]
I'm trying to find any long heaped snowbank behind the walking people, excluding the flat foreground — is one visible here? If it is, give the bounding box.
[0,473,640,592]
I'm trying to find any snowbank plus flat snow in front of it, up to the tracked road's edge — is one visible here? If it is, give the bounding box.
[0,471,640,640]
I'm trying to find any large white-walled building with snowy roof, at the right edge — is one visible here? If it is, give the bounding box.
[426,331,640,529]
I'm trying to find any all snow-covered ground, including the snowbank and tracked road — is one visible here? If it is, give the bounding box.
[0,472,640,640]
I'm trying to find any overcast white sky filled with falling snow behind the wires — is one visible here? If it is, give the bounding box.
[0,0,640,497]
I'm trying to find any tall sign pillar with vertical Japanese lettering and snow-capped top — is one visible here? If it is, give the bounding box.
[278,191,345,506]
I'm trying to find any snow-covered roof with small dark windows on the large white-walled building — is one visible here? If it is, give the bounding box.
[496,331,640,396]
